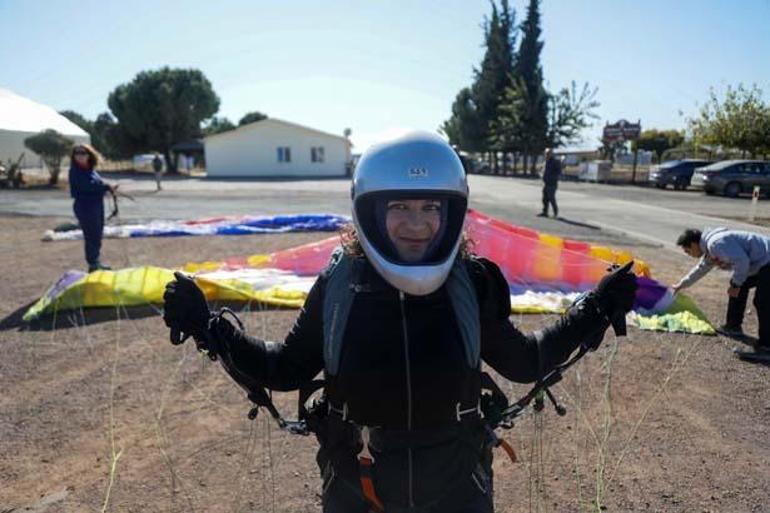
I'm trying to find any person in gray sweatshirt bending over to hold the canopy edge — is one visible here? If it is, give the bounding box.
[672,228,770,351]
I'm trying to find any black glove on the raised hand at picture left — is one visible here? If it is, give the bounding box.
[163,271,211,345]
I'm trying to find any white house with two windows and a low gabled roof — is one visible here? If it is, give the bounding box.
[203,118,350,178]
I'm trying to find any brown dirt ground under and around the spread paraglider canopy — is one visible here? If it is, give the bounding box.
[0,217,770,513]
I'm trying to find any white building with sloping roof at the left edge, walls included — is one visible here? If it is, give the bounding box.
[0,89,91,167]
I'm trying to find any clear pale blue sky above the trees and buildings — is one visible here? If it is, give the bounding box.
[0,0,770,152]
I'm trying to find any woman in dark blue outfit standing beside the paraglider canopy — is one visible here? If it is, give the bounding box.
[69,144,118,272]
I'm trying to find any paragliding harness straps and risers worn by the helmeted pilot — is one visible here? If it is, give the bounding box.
[186,252,626,513]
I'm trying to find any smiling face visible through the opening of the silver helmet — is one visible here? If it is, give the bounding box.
[385,199,441,263]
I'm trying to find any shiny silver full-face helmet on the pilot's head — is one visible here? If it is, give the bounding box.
[351,132,468,296]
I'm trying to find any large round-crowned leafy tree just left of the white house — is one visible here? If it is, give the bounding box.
[107,67,219,173]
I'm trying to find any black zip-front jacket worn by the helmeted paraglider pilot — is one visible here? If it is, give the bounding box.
[208,254,599,506]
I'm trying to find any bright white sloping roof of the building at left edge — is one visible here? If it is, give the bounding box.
[0,88,88,137]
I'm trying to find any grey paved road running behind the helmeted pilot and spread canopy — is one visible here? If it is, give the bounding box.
[0,175,770,249]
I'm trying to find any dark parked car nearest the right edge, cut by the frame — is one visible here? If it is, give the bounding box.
[691,160,770,198]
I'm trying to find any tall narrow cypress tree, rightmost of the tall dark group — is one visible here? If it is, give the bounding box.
[514,0,548,169]
